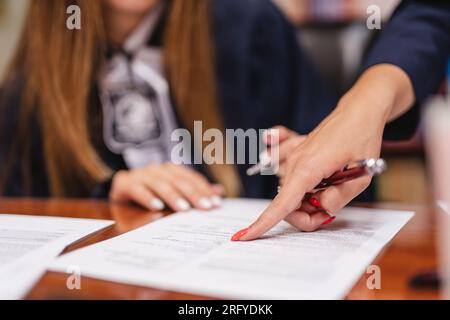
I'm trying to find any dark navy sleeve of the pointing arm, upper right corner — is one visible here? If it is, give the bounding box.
[365,0,450,103]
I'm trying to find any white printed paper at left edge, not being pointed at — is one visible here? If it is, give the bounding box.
[0,214,113,299]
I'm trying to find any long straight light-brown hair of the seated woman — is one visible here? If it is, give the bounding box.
[1,0,239,197]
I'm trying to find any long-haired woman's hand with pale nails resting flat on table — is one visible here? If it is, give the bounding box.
[109,163,223,211]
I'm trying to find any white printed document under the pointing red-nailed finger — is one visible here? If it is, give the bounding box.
[51,200,413,299]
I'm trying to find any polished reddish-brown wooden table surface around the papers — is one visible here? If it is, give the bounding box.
[0,198,440,300]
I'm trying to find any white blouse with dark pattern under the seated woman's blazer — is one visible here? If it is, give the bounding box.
[99,4,181,169]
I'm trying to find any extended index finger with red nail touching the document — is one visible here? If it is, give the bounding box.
[236,179,306,241]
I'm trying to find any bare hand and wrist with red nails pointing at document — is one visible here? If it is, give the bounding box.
[233,64,415,241]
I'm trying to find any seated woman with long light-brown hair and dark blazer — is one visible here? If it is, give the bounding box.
[0,0,333,211]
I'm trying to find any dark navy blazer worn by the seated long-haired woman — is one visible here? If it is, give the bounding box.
[0,0,335,197]
